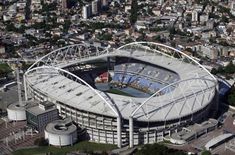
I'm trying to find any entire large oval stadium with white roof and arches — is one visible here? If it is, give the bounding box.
[24,42,217,147]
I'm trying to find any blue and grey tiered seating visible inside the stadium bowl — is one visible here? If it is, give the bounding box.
[111,63,179,94]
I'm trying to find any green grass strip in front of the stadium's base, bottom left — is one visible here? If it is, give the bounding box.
[13,141,117,155]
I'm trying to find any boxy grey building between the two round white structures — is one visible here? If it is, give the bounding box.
[26,102,59,132]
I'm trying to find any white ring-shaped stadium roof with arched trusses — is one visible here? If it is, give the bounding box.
[25,43,216,121]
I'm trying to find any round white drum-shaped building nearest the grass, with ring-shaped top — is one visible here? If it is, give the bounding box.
[45,119,77,146]
